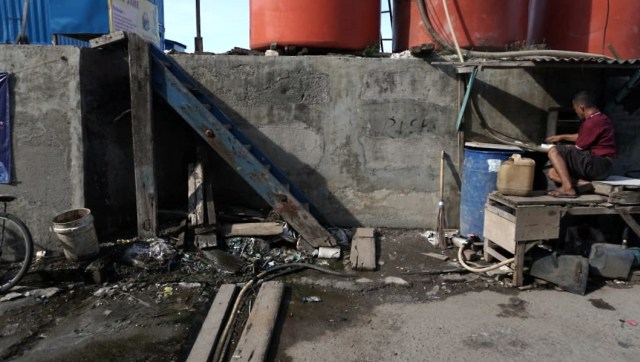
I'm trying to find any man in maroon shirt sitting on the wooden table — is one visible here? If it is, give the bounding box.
[547,91,616,198]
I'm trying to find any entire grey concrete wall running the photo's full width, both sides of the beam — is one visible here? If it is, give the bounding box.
[5,46,640,248]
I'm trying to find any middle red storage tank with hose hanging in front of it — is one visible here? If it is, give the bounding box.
[393,0,529,52]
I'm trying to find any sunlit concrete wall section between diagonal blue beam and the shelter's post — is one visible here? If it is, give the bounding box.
[176,56,458,227]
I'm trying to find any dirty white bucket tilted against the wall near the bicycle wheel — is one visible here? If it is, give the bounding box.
[53,209,100,261]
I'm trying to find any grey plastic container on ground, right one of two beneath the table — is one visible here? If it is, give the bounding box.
[589,243,635,279]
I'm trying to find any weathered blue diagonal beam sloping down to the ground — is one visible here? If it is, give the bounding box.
[151,47,335,247]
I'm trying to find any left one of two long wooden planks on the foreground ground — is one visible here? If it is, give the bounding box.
[187,284,236,362]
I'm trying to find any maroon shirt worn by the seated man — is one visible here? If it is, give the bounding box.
[576,112,616,157]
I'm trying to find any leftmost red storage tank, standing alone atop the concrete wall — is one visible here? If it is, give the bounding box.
[250,0,380,50]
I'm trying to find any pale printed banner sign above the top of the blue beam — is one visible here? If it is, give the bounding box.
[109,0,161,47]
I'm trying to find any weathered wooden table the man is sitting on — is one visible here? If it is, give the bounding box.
[484,192,640,286]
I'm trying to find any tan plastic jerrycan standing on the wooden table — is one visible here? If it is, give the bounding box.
[496,154,536,196]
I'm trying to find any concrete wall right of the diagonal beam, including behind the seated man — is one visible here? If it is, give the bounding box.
[176,55,640,227]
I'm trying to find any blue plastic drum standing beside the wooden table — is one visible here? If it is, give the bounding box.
[460,144,522,239]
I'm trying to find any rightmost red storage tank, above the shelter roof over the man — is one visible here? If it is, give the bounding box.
[528,0,640,59]
